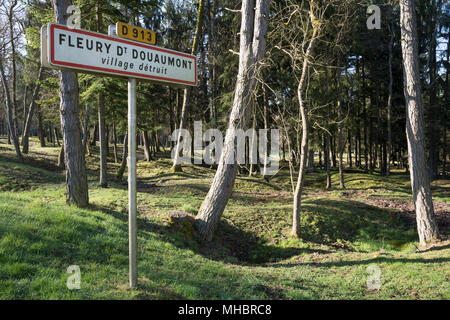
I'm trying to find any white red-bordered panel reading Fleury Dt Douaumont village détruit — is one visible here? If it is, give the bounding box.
[44,23,197,86]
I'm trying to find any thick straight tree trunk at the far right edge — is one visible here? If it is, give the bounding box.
[400,0,439,245]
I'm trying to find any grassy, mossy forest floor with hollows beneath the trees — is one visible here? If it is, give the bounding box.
[0,137,450,299]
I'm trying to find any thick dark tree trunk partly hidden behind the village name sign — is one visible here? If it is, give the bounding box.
[53,0,89,207]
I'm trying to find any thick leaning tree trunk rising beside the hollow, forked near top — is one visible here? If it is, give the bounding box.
[196,0,270,240]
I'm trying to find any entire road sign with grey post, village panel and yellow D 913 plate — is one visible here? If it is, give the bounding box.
[41,23,197,288]
